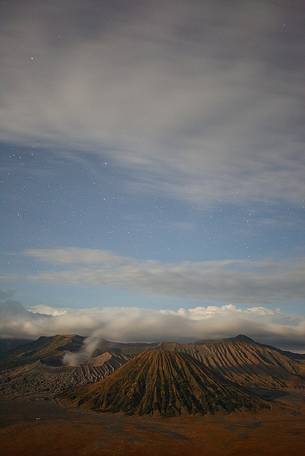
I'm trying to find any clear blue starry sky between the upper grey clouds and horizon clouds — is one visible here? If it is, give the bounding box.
[1,144,305,312]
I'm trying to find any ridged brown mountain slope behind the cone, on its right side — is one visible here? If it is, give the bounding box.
[162,336,304,389]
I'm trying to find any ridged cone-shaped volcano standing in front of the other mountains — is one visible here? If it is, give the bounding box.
[69,348,266,416]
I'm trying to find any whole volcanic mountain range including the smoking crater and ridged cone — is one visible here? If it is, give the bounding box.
[0,335,305,415]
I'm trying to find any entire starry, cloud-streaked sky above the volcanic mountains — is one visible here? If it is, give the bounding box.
[0,0,305,350]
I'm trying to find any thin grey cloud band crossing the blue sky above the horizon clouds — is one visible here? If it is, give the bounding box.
[24,248,305,307]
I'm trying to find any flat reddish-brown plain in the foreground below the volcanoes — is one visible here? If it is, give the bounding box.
[0,393,305,456]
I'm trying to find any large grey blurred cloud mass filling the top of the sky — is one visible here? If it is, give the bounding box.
[0,0,305,204]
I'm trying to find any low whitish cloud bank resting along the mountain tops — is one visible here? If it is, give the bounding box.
[0,290,305,350]
